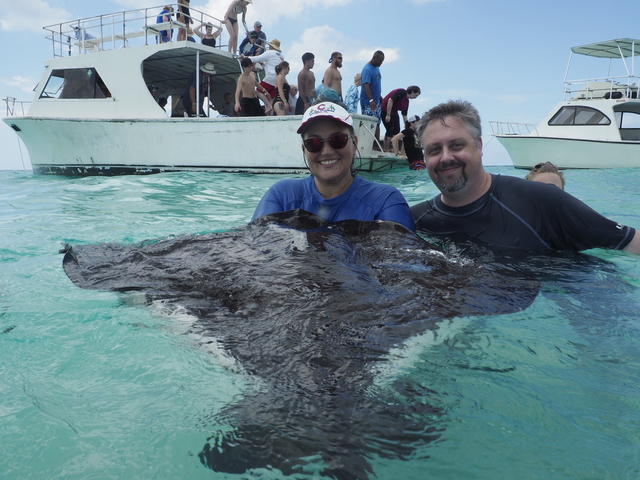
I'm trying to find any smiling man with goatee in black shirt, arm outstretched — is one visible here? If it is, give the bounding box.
[411,100,640,254]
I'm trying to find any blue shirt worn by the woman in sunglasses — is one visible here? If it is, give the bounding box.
[252,175,415,232]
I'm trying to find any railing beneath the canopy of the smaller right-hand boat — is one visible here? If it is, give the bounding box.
[564,75,640,101]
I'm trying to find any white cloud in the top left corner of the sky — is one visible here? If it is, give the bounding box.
[0,0,69,33]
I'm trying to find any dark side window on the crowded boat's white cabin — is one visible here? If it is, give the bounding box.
[40,68,111,98]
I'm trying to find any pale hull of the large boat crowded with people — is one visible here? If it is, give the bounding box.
[4,115,407,176]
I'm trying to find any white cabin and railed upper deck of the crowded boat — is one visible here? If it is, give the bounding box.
[29,7,242,118]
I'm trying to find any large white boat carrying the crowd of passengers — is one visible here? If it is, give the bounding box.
[3,5,406,175]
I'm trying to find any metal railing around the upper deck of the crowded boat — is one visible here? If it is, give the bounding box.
[44,4,225,57]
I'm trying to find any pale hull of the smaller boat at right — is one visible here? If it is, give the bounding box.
[496,135,640,169]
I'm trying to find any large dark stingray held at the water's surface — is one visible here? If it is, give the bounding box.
[63,210,539,480]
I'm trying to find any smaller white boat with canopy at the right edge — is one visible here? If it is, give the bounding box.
[491,38,640,169]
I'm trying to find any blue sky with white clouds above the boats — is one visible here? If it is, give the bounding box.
[0,0,640,170]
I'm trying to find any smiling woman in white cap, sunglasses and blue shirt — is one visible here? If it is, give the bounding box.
[253,102,415,231]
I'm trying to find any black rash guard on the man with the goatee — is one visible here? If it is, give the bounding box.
[411,175,635,251]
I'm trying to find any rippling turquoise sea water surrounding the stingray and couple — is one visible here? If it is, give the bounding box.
[0,167,640,479]
